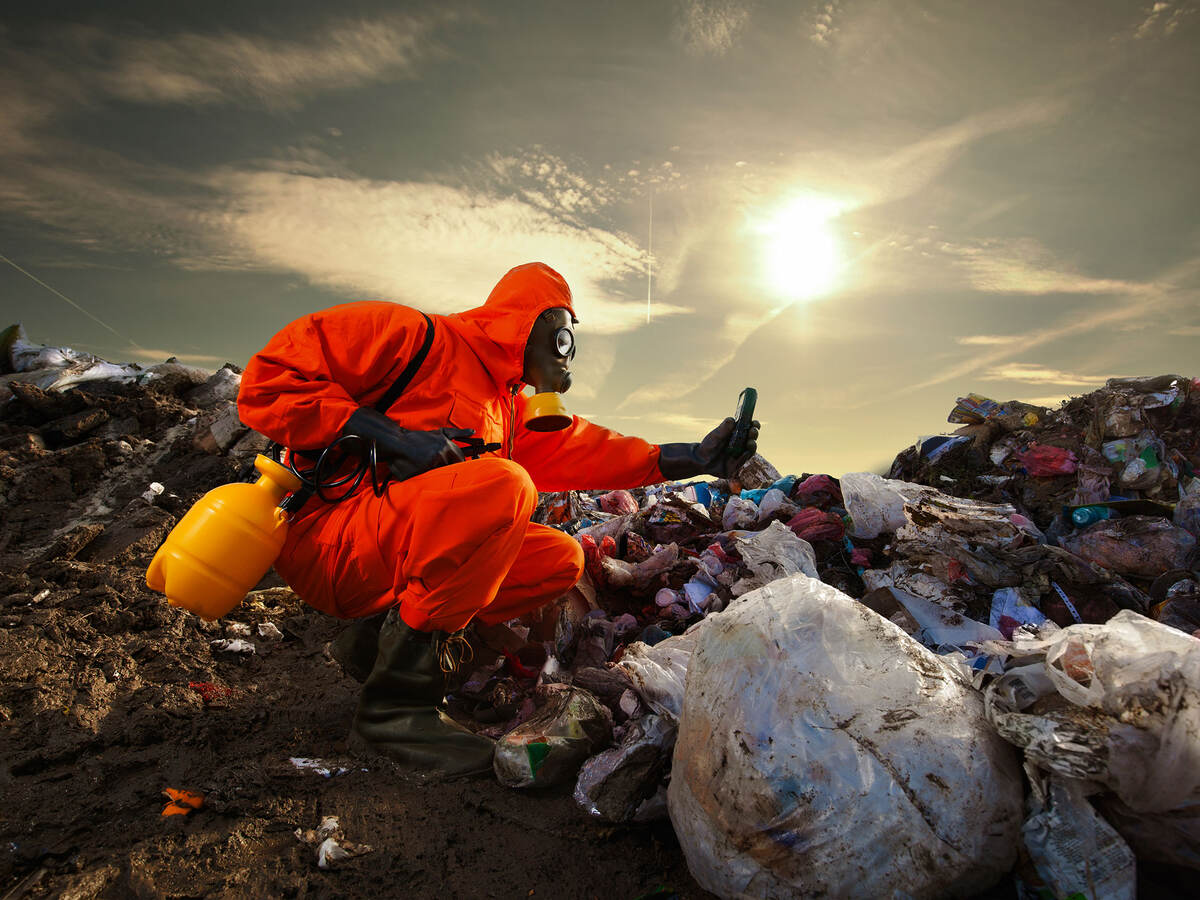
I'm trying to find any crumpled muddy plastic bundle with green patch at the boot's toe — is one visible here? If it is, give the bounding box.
[492,688,612,787]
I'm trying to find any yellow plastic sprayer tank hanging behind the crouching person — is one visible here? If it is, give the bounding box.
[146,454,300,619]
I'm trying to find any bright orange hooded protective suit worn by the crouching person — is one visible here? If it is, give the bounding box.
[238,263,662,631]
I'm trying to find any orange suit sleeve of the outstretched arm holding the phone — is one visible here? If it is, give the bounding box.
[512,397,664,491]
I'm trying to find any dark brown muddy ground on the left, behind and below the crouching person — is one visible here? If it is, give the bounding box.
[0,355,708,898]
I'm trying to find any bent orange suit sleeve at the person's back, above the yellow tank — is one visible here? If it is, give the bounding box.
[238,302,426,450]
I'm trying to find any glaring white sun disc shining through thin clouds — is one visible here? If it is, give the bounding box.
[762,197,841,300]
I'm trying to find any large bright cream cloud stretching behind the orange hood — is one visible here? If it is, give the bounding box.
[202,172,685,335]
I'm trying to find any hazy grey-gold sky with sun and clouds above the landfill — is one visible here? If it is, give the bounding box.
[0,0,1200,475]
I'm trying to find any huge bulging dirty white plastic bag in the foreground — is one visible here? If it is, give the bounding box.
[667,575,1022,898]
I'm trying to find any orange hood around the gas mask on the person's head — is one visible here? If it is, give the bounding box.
[446,263,575,386]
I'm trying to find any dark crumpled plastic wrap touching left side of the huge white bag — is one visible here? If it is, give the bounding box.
[575,714,676,822]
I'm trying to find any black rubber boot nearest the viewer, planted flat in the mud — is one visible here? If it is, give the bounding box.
[350,610,496,778]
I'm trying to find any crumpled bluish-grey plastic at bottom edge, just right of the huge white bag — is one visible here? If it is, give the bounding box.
[1021,768,1138,900]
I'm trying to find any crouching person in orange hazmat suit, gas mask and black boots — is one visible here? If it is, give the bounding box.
[238,263,758,775]
